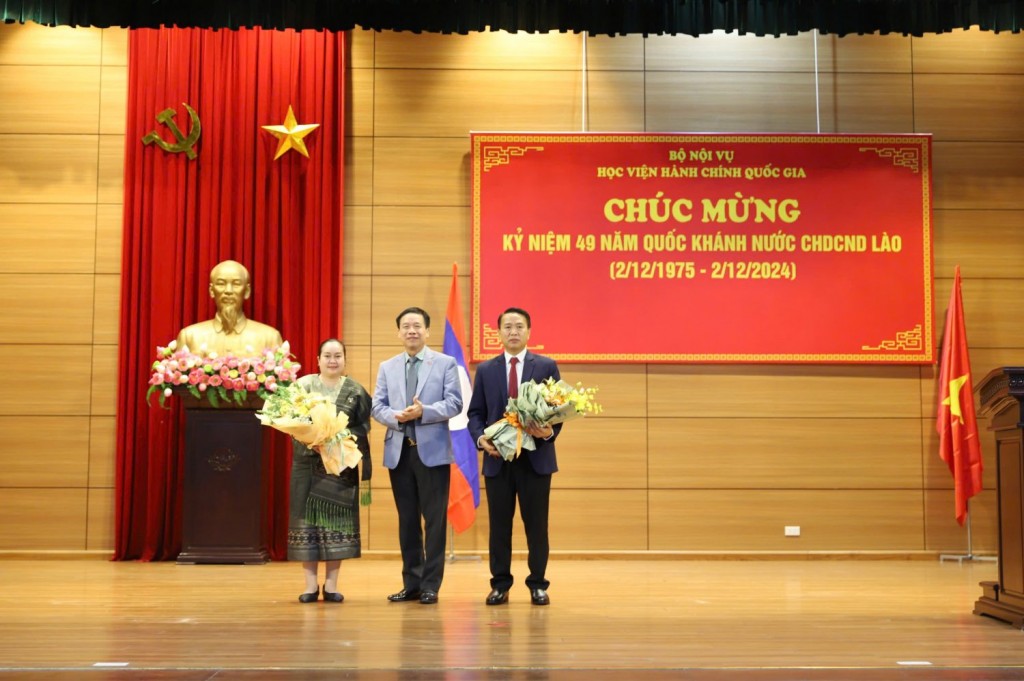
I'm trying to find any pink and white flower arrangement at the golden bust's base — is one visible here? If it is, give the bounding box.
[145,341,301,407]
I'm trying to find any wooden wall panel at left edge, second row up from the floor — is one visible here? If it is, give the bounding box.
[0,416,89,488]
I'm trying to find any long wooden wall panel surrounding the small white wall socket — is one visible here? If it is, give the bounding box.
[649,490,925,551]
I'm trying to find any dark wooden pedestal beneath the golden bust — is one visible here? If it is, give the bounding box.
[175,390,270,564]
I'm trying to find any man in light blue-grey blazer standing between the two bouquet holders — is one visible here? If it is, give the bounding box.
[372,307,462,604]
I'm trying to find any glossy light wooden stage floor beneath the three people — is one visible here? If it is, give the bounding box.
[0,556,1024,681]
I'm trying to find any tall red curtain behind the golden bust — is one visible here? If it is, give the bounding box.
[115,29,345,560]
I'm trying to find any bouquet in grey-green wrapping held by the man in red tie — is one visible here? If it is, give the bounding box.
[483,378,601,461]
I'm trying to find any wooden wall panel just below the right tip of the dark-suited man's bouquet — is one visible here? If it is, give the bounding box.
[551,418,648,491]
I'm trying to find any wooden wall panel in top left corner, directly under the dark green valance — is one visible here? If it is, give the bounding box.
[0,24,102,66]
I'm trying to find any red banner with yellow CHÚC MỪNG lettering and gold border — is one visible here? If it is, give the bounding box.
[471,133,934,364]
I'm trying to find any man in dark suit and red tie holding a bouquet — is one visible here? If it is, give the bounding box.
[467,307,561,605]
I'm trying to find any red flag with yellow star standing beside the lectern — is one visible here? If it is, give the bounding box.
[935,265,982,525]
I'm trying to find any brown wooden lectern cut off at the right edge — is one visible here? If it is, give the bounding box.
[974,367,1024,629]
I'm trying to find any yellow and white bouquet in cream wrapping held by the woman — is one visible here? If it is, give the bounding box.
[256,383,362,475]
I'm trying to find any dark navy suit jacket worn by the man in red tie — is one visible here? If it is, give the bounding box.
[467,350,561,477]
